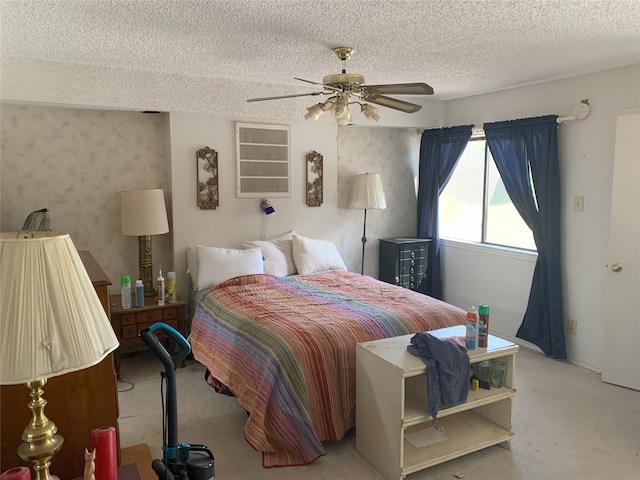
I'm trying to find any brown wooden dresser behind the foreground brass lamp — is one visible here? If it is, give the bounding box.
[0,252,120,480]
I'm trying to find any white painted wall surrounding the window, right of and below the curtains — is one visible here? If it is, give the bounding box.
[443,65,640,370]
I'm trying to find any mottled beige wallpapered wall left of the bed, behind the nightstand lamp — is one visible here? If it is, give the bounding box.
[0,104,172,293]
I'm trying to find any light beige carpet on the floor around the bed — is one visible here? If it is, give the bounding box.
[118,347,640,480]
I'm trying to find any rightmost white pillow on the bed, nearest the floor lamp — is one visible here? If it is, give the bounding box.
[292,235,347,275]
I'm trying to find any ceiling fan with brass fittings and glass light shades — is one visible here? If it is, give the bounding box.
[247,47,433,125]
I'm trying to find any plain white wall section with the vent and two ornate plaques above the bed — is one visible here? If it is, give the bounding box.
[170,113,344,298]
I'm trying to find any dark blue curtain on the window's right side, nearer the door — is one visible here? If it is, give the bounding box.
[484,115,567,358]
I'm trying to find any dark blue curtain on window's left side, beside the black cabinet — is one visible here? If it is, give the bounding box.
[417,125,473,299]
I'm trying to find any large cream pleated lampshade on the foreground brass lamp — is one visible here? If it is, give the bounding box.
[0,232,118,385]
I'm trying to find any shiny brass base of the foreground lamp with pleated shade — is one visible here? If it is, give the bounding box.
[18,378,64,480]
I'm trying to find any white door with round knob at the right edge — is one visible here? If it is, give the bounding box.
[602,109,640,390]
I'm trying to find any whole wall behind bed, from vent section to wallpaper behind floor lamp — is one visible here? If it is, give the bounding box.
[165,109,442,296]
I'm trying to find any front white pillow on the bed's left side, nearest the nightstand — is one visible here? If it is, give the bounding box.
[196,245,264,290]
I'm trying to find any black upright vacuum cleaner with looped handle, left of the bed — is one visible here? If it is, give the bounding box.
[138,323,215,480]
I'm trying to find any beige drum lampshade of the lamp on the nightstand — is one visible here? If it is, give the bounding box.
[120,188,169,236]
